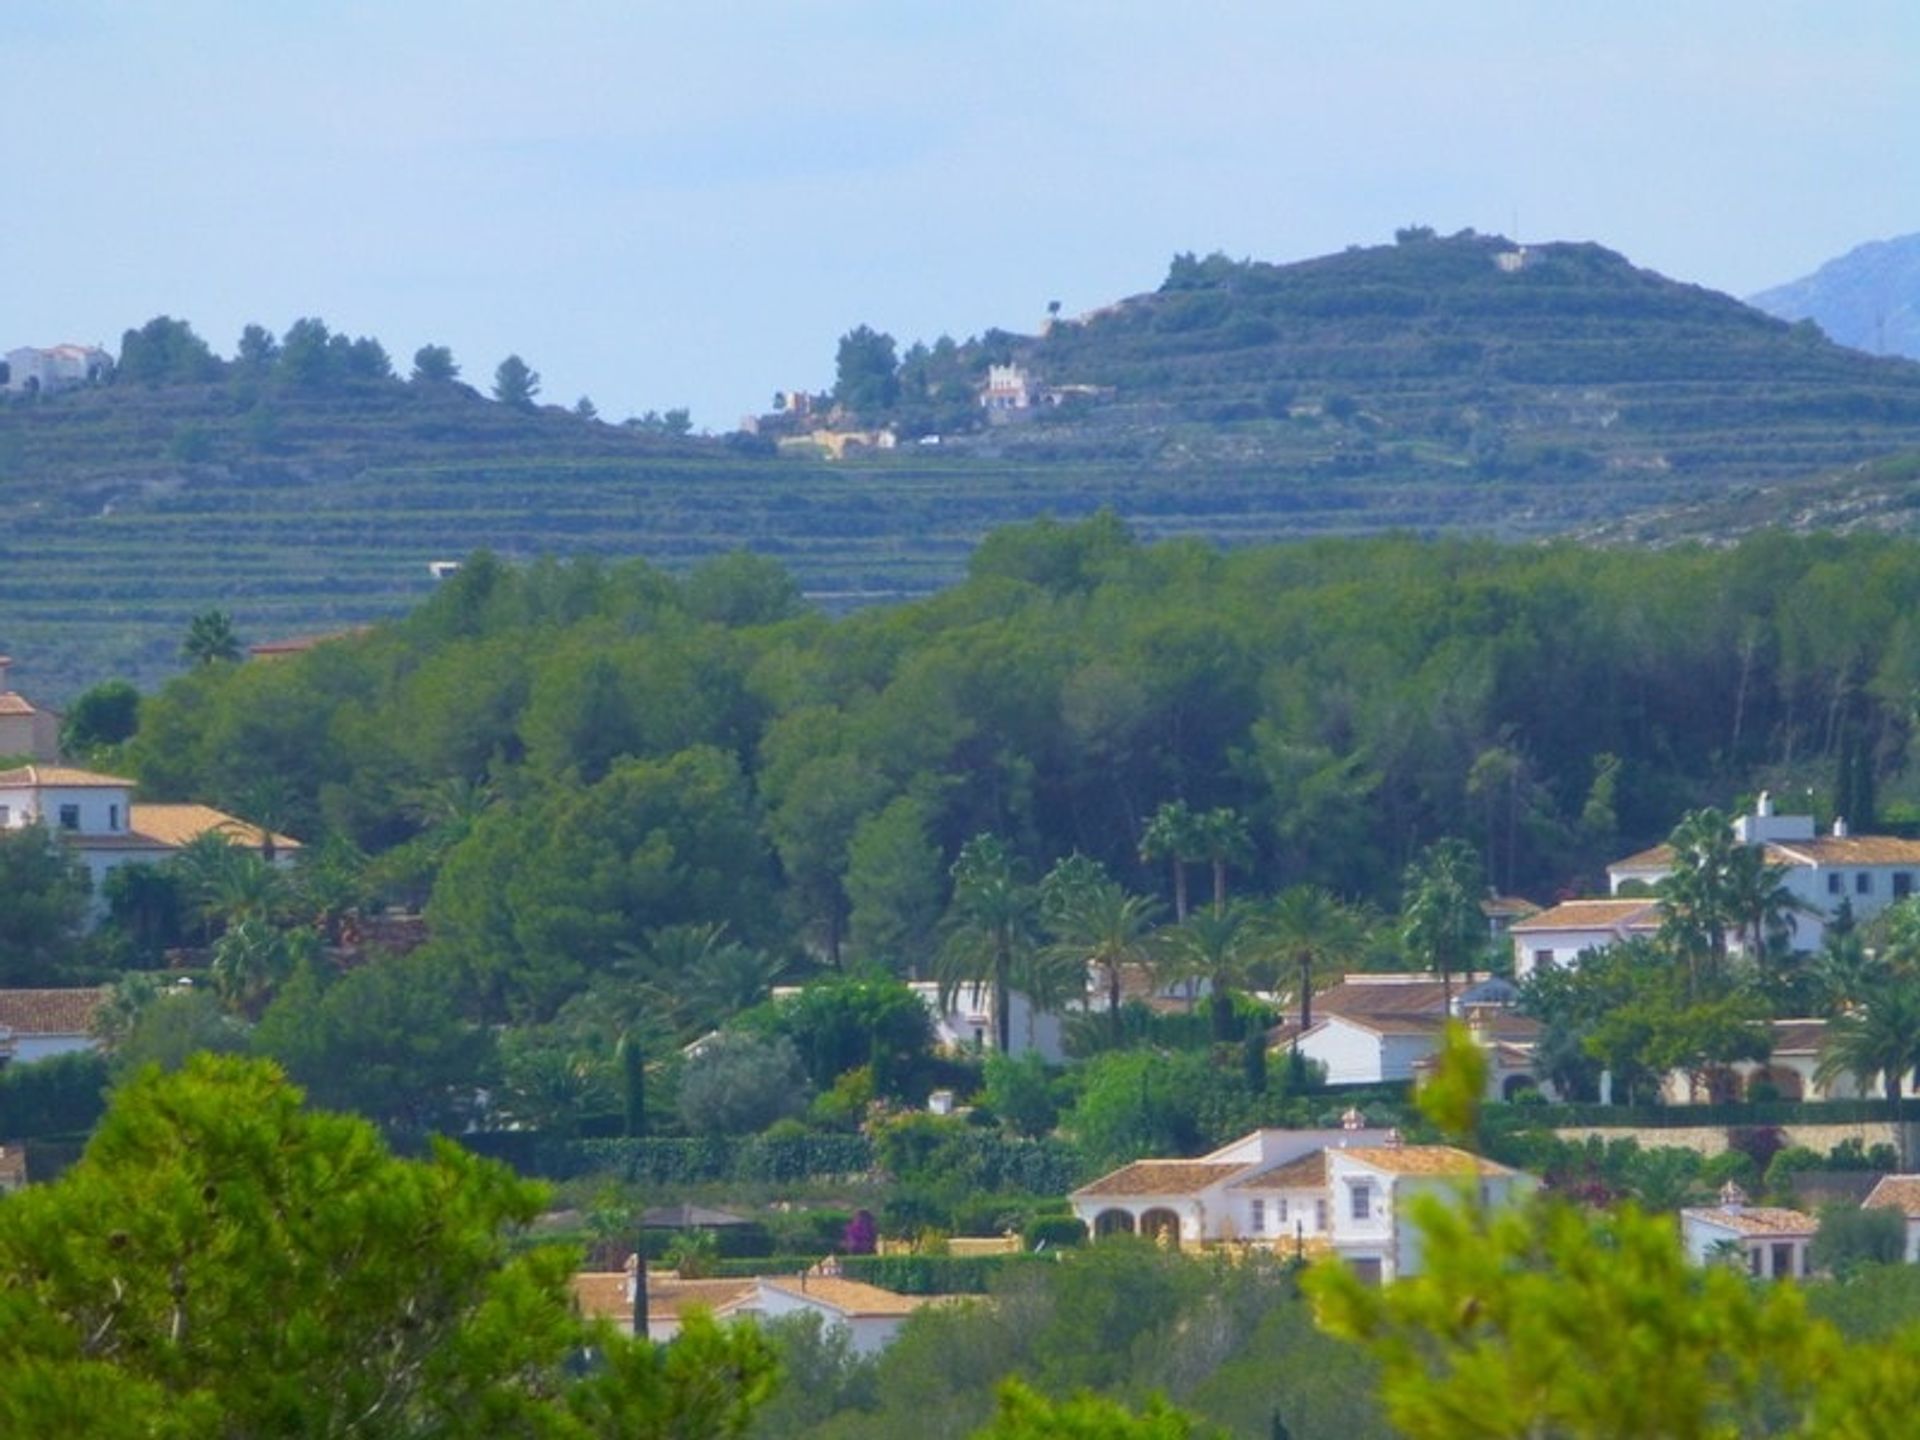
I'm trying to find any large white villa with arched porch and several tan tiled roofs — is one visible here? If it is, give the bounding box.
[1069,1112,1534,1281]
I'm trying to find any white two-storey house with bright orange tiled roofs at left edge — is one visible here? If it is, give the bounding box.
[0,764,300,922]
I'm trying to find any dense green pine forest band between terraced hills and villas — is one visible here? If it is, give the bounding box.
[117,516,1920,964]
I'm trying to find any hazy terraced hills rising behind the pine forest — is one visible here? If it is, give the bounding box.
[11,230,1920,699]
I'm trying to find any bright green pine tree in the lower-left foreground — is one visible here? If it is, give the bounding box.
[0,1058,774,1440]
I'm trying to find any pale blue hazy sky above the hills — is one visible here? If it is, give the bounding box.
[0,0,1920,430]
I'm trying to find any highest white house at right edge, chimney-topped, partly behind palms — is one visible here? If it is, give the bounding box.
[1605,791,1920,952]
